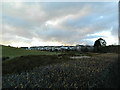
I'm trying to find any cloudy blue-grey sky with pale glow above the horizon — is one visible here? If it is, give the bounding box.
[0,2,118,47]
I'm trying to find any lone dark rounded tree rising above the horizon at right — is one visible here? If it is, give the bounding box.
[94,38,106,52]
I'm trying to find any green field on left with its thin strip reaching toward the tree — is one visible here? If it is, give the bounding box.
[0,46,97,59]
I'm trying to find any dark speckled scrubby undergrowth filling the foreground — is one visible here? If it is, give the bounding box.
[2,54,119,89]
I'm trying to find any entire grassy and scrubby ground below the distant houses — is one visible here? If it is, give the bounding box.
[2,46,120,89]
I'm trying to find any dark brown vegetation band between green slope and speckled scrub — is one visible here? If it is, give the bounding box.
[2,55,69,74]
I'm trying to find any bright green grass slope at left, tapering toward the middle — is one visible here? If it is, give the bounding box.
[2,46,59,58]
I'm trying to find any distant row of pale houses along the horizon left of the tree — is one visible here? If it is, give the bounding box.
[27,45,94,52]
